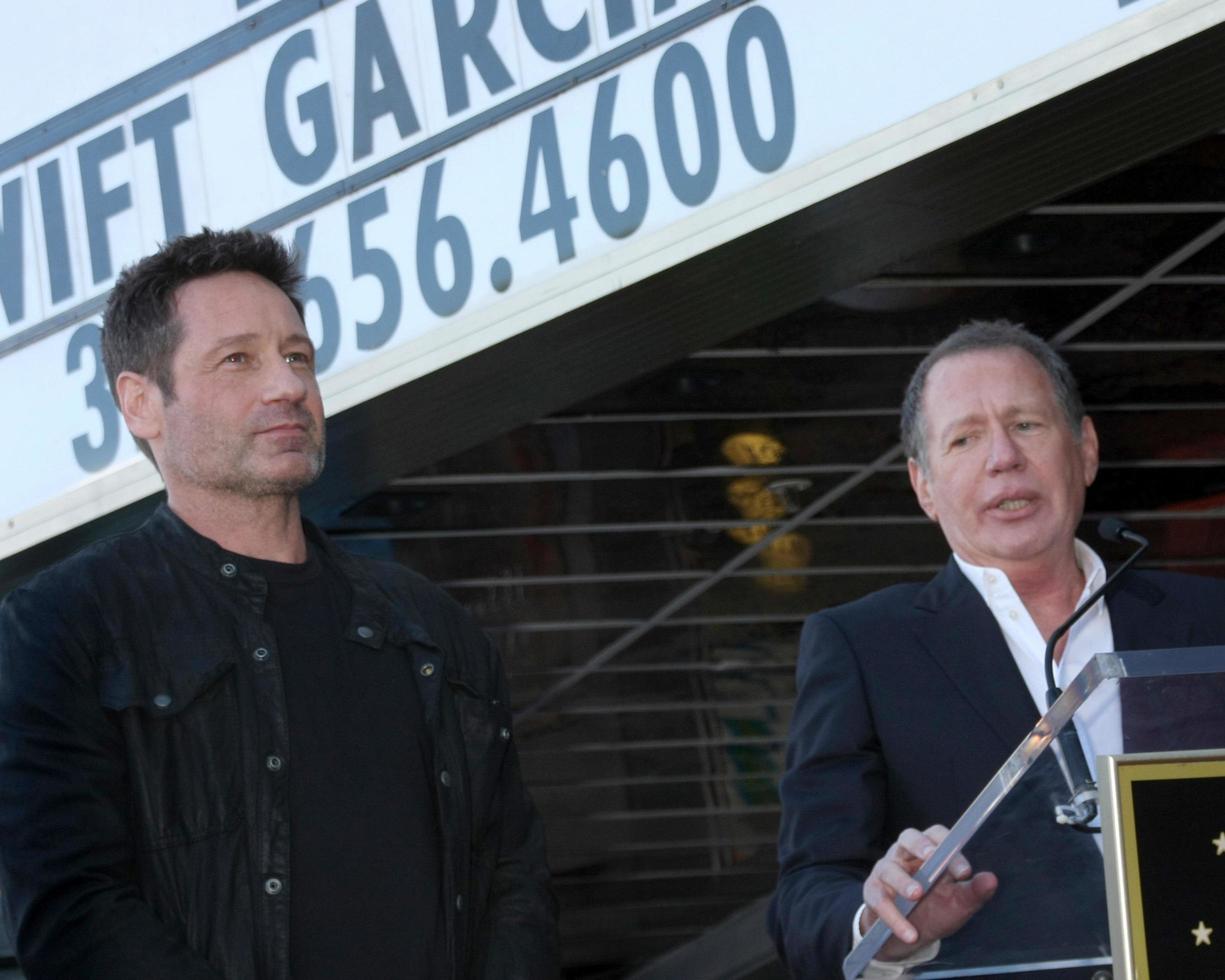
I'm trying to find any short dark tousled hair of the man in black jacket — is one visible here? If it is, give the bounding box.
[102,228,303,459]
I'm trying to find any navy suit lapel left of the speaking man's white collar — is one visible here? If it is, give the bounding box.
[915,557,1039,751]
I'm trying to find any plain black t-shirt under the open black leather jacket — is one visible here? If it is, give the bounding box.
[249,548,445,980]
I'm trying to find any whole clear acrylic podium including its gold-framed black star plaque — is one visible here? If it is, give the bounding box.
[843,647,1225,980]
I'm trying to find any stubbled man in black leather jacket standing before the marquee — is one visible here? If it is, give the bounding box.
[0,225,557,980]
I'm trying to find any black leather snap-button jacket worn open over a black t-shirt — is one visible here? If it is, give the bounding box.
[0,505,557,980]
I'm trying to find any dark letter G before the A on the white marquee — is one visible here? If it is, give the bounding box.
[263,29,336,184]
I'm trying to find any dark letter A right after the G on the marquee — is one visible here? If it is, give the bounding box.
[353,0,421,160]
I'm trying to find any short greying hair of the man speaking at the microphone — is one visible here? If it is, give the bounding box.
[902,320,1084,472]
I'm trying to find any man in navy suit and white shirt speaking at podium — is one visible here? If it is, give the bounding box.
[769,323,1225,978]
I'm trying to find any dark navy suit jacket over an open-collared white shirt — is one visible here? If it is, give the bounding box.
[769,559,1225,980]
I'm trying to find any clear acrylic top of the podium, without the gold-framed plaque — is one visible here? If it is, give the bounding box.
[843,647,1225,980]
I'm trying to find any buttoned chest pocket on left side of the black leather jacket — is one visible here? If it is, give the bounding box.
[99,659,243,849]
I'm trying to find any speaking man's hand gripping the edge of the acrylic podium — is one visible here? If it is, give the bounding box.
[860,823,1000,959]
